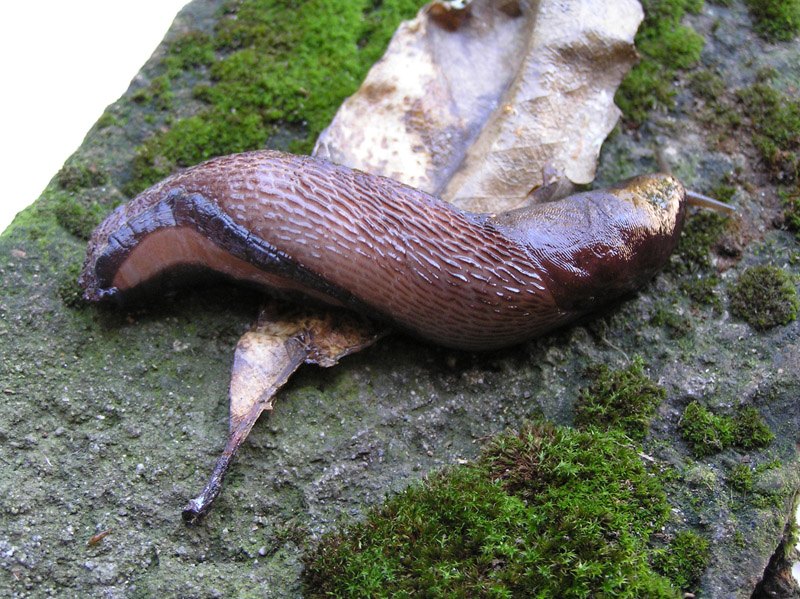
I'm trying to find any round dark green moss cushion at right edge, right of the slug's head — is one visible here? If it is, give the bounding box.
[730,265,800,331]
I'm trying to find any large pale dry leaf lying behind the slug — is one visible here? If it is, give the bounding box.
[315,0,643,212]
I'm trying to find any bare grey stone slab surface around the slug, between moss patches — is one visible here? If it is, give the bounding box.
[0,2,800,598]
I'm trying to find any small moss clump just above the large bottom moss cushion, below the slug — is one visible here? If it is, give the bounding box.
[575,358,667,439]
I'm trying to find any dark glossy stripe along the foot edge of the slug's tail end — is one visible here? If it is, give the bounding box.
[86,189,373,312]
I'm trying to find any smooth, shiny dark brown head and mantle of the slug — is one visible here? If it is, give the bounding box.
[489,174,686,313]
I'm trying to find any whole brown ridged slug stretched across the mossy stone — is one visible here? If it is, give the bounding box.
[81,151,686,349]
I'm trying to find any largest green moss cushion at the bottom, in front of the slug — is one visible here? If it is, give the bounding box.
[305,424,688,598]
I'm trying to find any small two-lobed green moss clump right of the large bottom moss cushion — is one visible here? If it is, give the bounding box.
[679,401,775,458]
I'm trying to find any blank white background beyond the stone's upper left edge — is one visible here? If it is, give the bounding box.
[0,0,188,231]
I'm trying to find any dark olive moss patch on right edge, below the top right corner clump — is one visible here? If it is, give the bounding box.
[737,72,800,182]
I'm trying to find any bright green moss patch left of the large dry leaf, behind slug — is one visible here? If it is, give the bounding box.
[125,0,423,195]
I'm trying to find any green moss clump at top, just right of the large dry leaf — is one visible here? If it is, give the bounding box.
[615,0,703,124]
